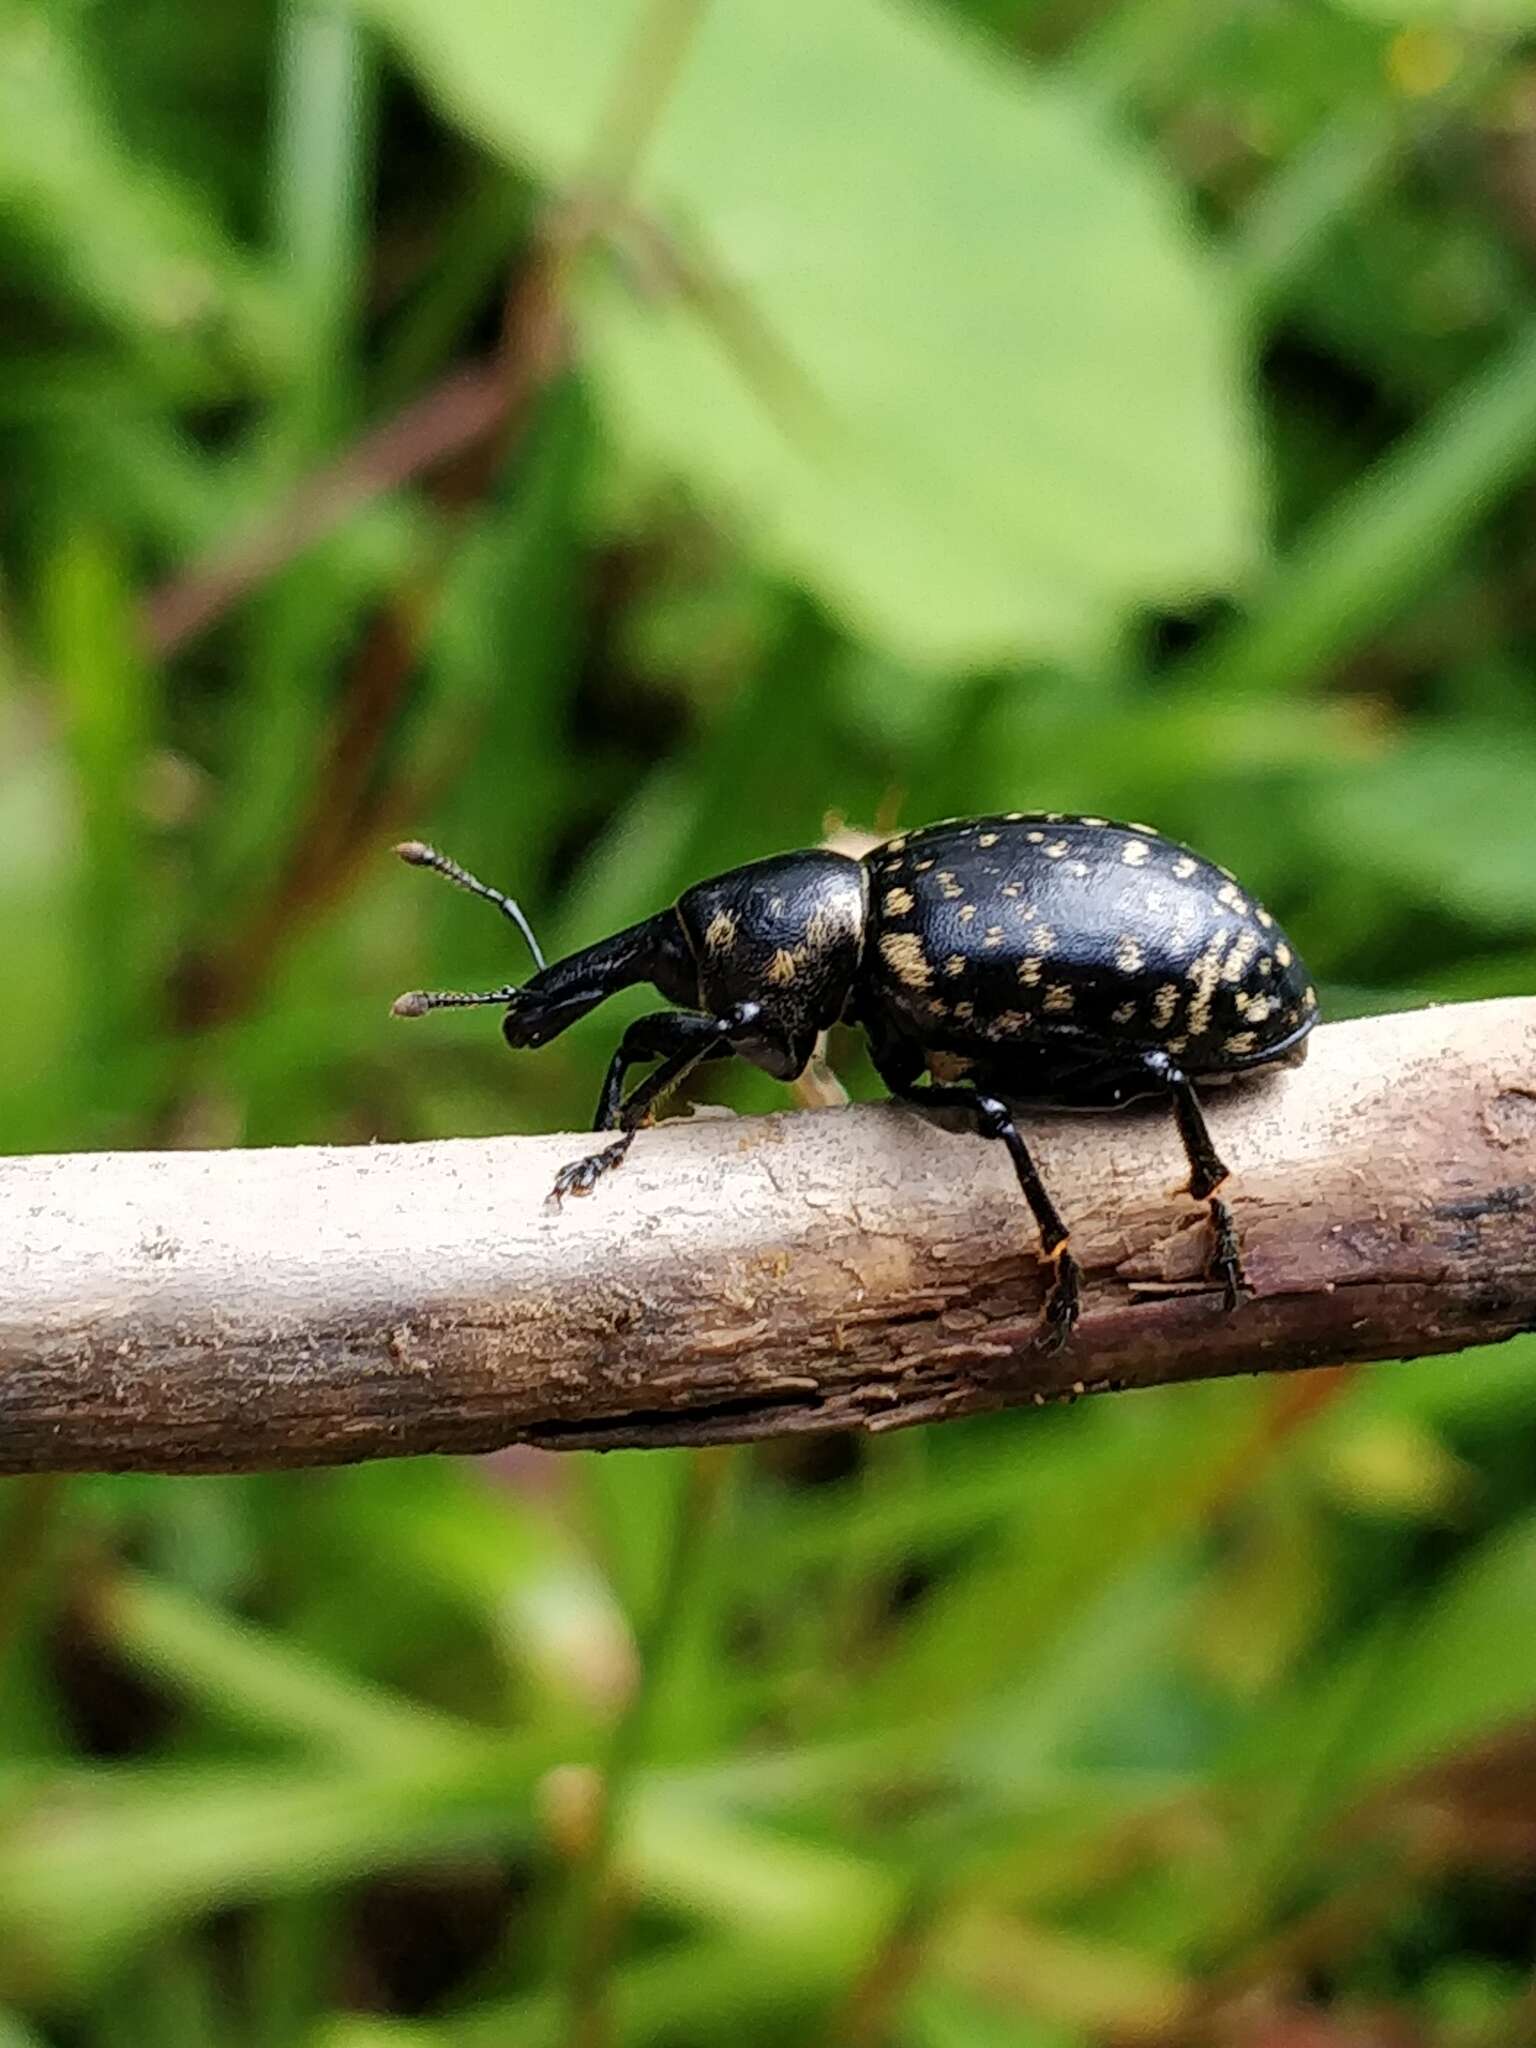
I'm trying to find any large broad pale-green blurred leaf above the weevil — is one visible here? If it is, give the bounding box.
[367,0,1255,664]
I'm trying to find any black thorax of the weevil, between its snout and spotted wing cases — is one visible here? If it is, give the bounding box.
[668,850,866,1079]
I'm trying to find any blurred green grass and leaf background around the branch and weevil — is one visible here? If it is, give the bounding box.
[0,0,1536,2048]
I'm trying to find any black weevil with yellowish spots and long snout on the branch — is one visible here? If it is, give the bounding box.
[395,811,1317,1343]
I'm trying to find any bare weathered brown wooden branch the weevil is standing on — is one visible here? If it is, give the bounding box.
[0,999,1536,1473]
